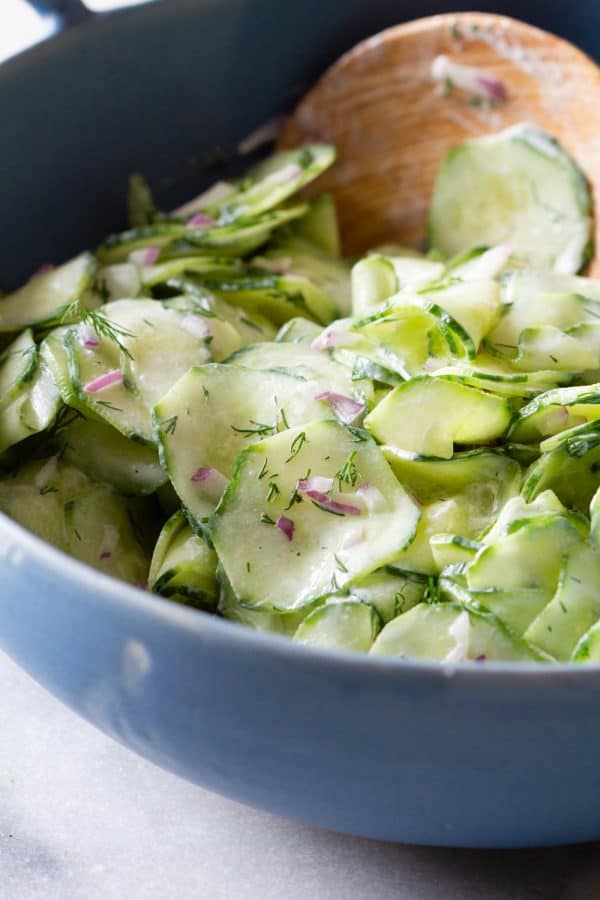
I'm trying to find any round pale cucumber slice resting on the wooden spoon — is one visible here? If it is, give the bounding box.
[429,124,592,275]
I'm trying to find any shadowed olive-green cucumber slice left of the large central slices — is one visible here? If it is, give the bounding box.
[57,417,168,494]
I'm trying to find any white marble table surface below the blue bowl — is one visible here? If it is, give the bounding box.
[0,654,600,900]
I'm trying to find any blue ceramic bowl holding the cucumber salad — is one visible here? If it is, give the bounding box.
[0,0,600,847]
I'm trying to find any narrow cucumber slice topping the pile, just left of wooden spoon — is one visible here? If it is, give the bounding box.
[209,144,335,222]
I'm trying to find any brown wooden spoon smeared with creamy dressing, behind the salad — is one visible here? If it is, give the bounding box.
[279,13,600,276]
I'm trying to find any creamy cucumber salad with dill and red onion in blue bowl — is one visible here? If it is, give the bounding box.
[0,125,600,664]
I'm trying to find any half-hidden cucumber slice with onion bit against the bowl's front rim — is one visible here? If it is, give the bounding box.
[371,603,541,663]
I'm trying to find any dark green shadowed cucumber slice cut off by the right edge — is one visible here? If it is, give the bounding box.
[522,420,600,513]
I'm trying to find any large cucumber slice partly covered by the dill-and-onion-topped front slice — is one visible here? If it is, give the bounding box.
[154,364,360,519]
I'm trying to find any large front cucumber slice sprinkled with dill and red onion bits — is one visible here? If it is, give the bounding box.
[211,421,419,611]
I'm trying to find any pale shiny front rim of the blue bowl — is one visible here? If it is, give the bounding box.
[0,512,600,686]
